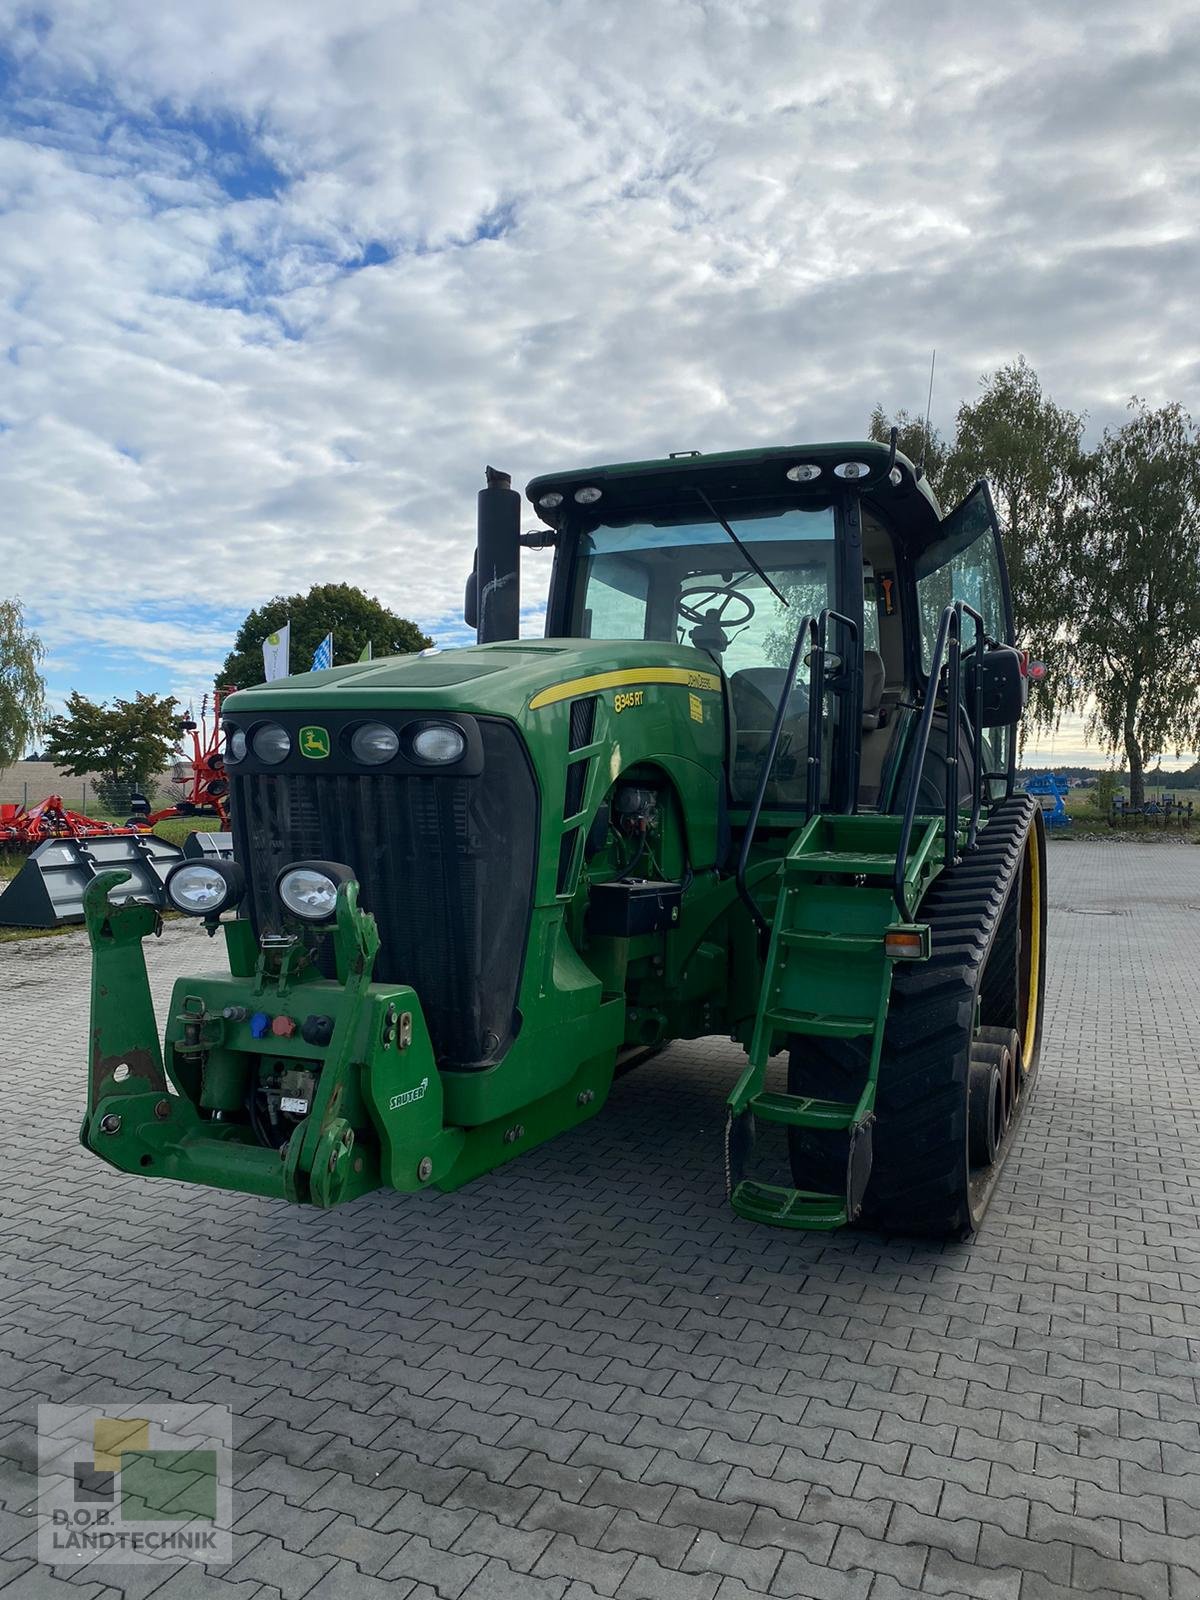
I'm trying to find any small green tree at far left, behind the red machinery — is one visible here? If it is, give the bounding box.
[46,690,179,811]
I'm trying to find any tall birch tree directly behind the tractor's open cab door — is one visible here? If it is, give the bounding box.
[944,355,1083,725]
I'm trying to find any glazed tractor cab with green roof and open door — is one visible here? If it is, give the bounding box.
[470,442,1024,814]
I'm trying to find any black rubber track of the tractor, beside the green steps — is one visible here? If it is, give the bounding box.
[789,795,1035,1237]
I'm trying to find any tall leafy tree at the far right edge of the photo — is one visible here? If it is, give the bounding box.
[1059,400,1200,805]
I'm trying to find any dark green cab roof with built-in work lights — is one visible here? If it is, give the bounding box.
[525,438,942,549]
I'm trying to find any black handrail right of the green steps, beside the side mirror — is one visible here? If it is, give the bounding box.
[891,600,986,922]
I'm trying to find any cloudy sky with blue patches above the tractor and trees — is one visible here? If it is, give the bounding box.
[0,0,1200,762]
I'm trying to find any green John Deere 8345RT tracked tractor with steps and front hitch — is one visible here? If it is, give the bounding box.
[82,437,1046,1237]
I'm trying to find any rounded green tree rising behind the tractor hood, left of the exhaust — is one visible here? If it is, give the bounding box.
[218,584,434,690]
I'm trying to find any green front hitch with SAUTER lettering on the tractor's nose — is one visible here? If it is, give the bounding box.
[80,872,462,1206]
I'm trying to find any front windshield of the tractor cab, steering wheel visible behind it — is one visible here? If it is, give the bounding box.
[573,507,837,805]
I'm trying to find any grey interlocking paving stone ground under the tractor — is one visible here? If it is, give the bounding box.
[0,843,1200,1600]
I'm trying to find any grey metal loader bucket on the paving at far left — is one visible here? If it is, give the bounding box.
[0,834,184,928]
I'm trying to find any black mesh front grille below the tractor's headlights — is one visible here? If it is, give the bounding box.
[232,718,538,1067]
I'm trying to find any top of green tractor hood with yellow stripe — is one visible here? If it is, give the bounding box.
[224,638,720,720]
